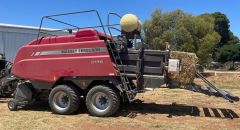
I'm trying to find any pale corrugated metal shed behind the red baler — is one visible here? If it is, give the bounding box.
[0,23,69,62]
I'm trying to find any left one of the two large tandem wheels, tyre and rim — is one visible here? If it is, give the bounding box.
[49,85,80,115]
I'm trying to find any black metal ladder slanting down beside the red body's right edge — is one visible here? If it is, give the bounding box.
[107,41,136,102]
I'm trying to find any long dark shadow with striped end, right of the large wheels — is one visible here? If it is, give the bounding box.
[117,100,239,119]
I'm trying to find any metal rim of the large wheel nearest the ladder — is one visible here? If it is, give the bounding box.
[91,92,110,112]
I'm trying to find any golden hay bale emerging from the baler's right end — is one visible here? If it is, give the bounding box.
[168,51,197,85]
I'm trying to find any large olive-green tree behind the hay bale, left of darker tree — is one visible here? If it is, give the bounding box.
[143,9,220,65]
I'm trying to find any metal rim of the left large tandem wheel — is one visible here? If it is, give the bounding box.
[53,91,70,110]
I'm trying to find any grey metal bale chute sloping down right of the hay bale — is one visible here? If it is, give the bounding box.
[186,72,239,103]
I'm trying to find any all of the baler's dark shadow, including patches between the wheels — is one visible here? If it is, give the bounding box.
[7,100,239,119]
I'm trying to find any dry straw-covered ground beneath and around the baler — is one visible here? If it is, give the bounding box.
[0,75,240,130]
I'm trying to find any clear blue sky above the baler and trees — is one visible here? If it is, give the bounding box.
[0,0,240,37]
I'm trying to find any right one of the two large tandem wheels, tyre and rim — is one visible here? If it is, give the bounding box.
[86,85,120,117]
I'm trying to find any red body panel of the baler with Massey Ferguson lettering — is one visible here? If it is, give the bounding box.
[12,30,119,82]
